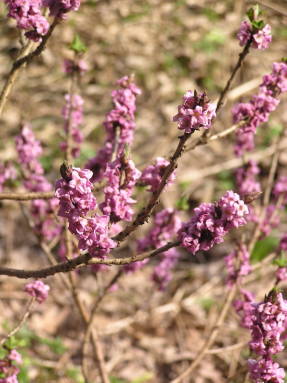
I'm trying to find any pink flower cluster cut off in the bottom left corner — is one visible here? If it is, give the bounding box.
[0,349,22,383]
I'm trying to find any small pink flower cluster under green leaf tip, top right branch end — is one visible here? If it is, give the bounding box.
[237,20,272,50]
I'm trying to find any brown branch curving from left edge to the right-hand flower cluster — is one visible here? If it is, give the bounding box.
[0,241,180,279]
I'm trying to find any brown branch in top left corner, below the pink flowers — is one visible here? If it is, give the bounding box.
[0,17,59,117]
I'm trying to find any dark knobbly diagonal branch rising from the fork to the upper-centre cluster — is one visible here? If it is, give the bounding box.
[113,133,190,242]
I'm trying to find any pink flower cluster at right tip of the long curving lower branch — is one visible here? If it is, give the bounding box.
[179,191,248,254]
